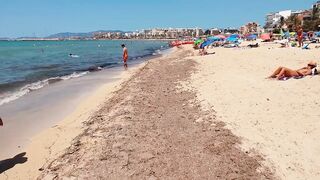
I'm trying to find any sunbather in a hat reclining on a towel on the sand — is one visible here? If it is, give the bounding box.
[269,61,317,80]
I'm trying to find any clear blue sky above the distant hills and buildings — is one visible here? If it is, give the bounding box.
[0,0,315,37]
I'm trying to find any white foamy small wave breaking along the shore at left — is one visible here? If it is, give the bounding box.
[0,71,88,106]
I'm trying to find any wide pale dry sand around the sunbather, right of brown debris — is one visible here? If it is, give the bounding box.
[192,43,320,180]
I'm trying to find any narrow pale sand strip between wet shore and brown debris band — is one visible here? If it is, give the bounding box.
[0,57,152,179]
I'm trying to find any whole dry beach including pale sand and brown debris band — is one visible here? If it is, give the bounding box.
[0,43,320,179]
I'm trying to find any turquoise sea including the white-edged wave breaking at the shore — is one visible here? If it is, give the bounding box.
[0,40,168,106]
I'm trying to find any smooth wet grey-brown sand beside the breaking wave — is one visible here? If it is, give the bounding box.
[0,67,123,159]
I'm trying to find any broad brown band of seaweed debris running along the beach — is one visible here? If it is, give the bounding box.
[32,48,274,179]
